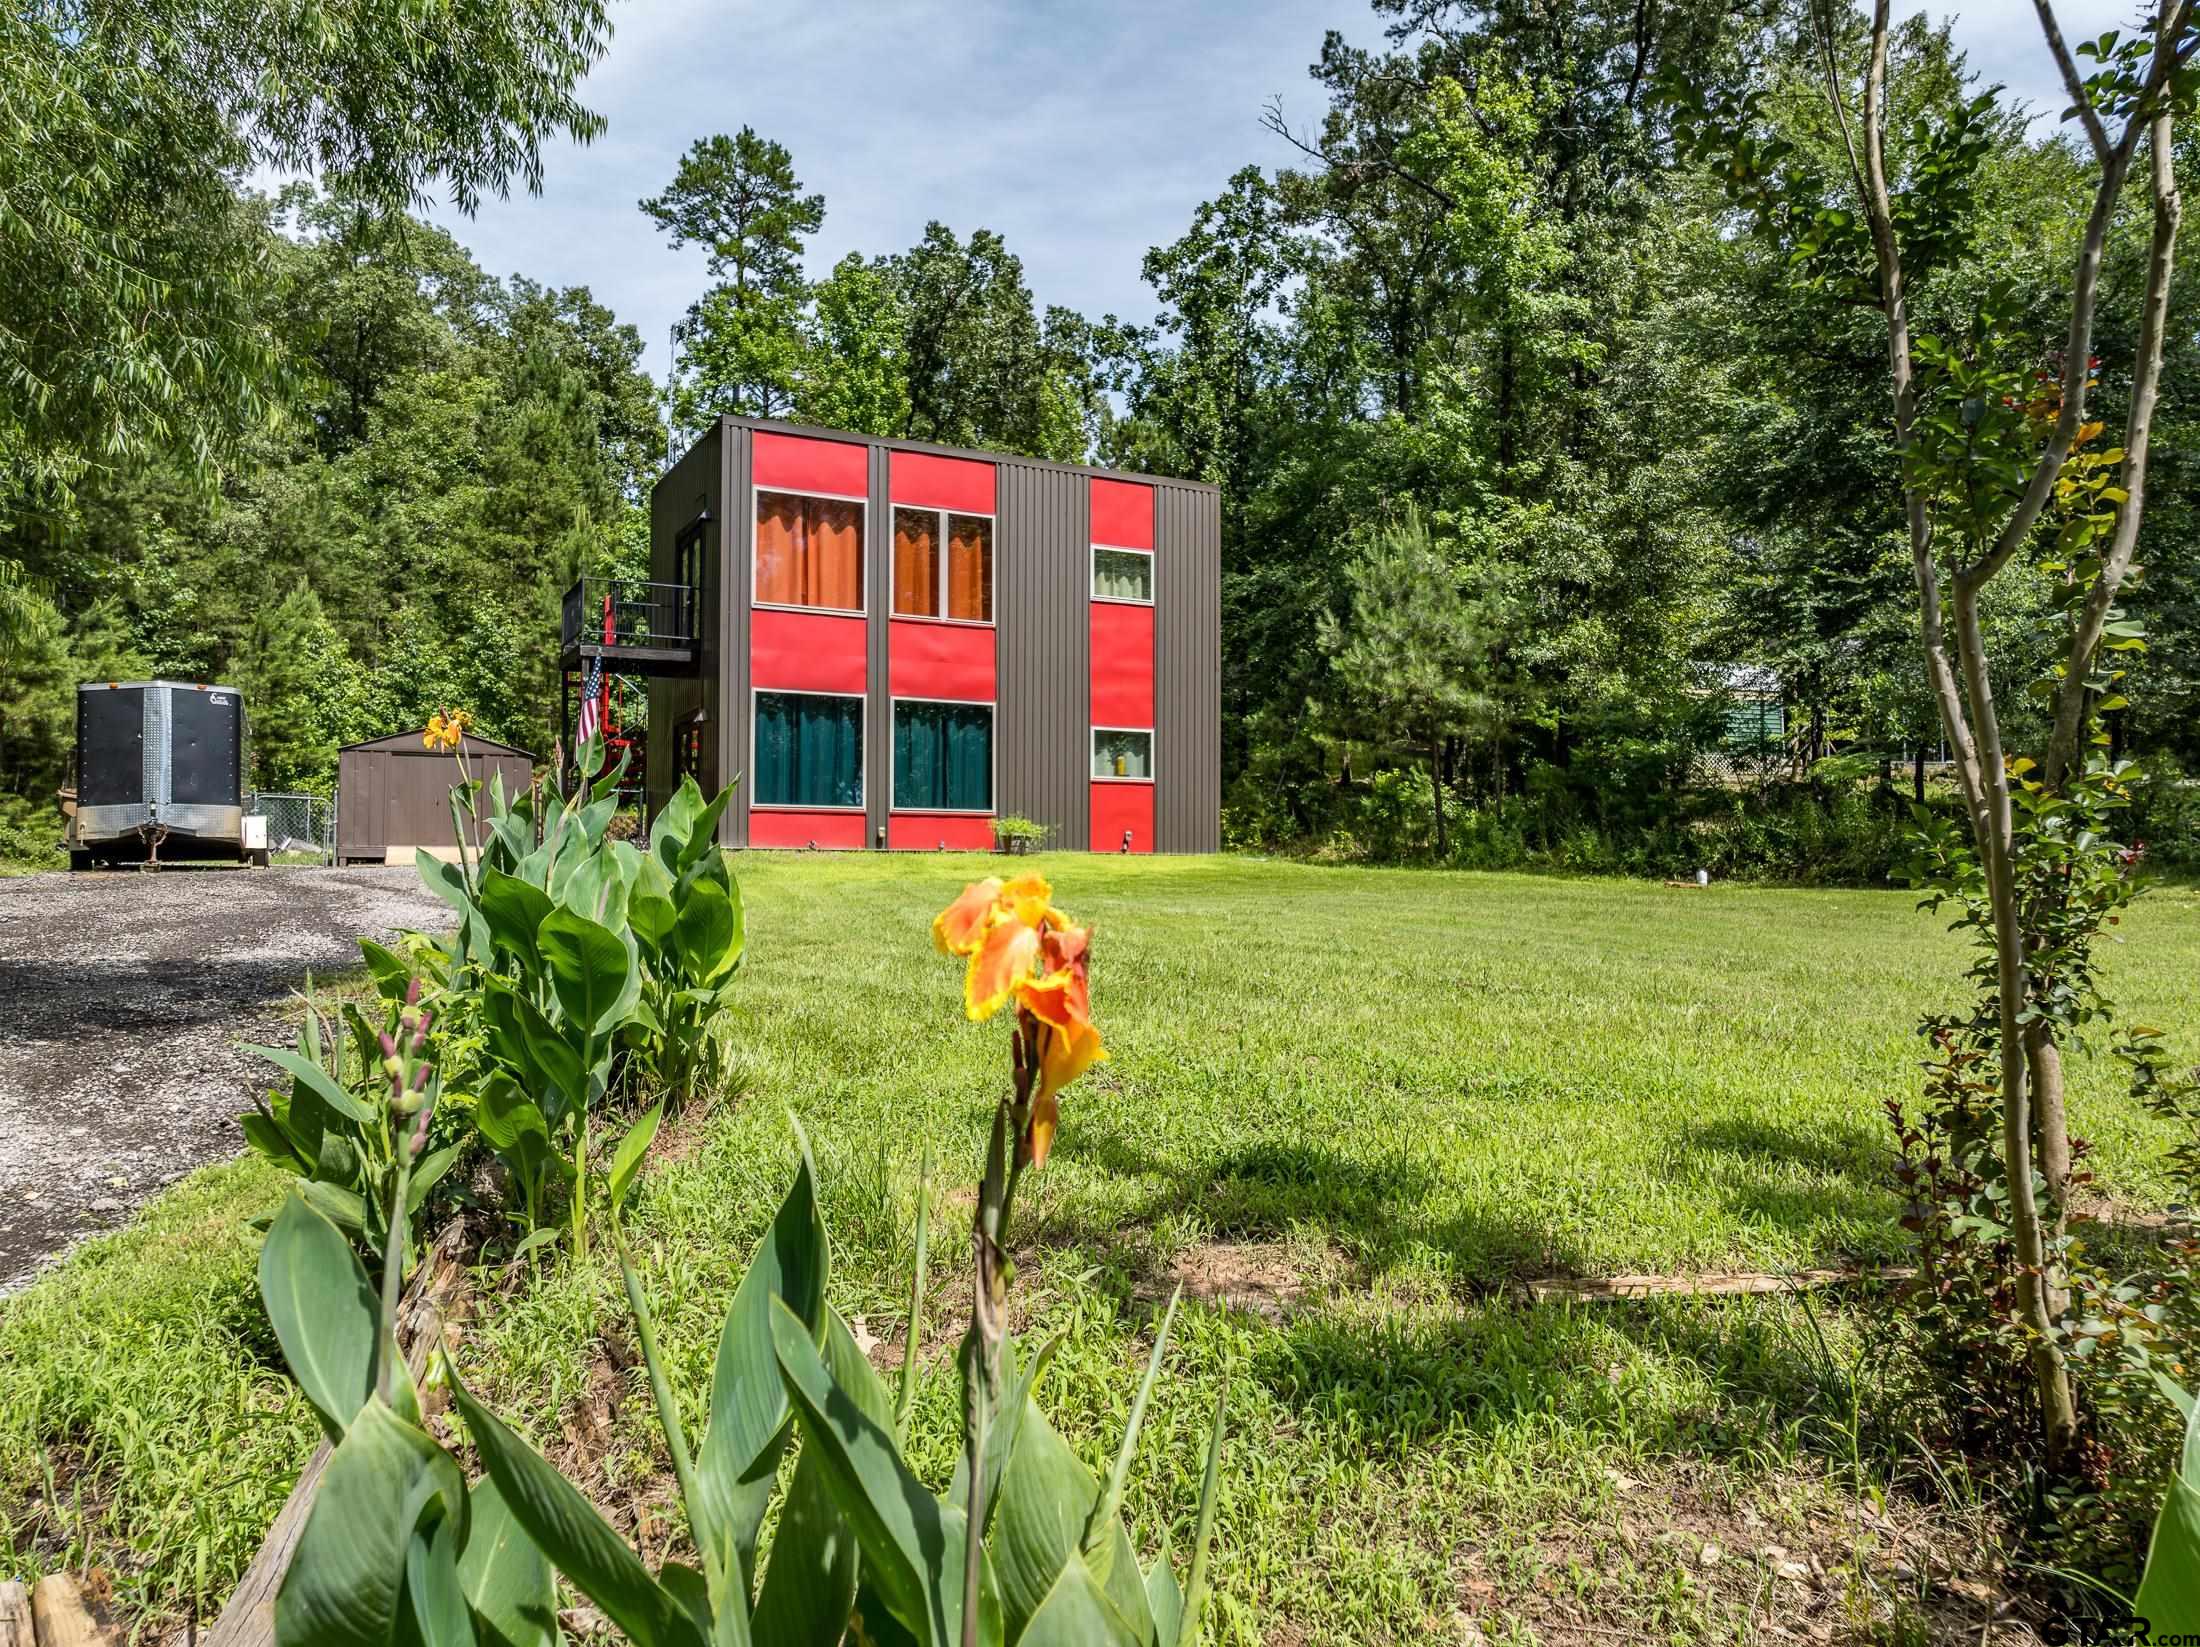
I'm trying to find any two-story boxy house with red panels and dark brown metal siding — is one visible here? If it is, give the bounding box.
[565,418,1221,853]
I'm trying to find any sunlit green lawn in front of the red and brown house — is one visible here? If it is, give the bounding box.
[0,853,2200,1643]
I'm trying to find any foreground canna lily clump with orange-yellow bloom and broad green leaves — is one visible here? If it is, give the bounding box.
[262,880,1223,1647]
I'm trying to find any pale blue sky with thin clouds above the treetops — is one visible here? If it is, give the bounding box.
[420,0,2121,378]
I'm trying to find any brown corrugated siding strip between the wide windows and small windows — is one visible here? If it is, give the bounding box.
[994,457,1091,851]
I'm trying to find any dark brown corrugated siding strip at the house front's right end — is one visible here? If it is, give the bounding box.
[1153,482,1223,853]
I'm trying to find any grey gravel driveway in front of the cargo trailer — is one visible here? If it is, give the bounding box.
[0,869,447,1293]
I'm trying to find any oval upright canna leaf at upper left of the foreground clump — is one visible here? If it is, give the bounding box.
[260,1196,383,1442]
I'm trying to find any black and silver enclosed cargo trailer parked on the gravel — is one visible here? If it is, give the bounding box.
[68,679,266,869]
